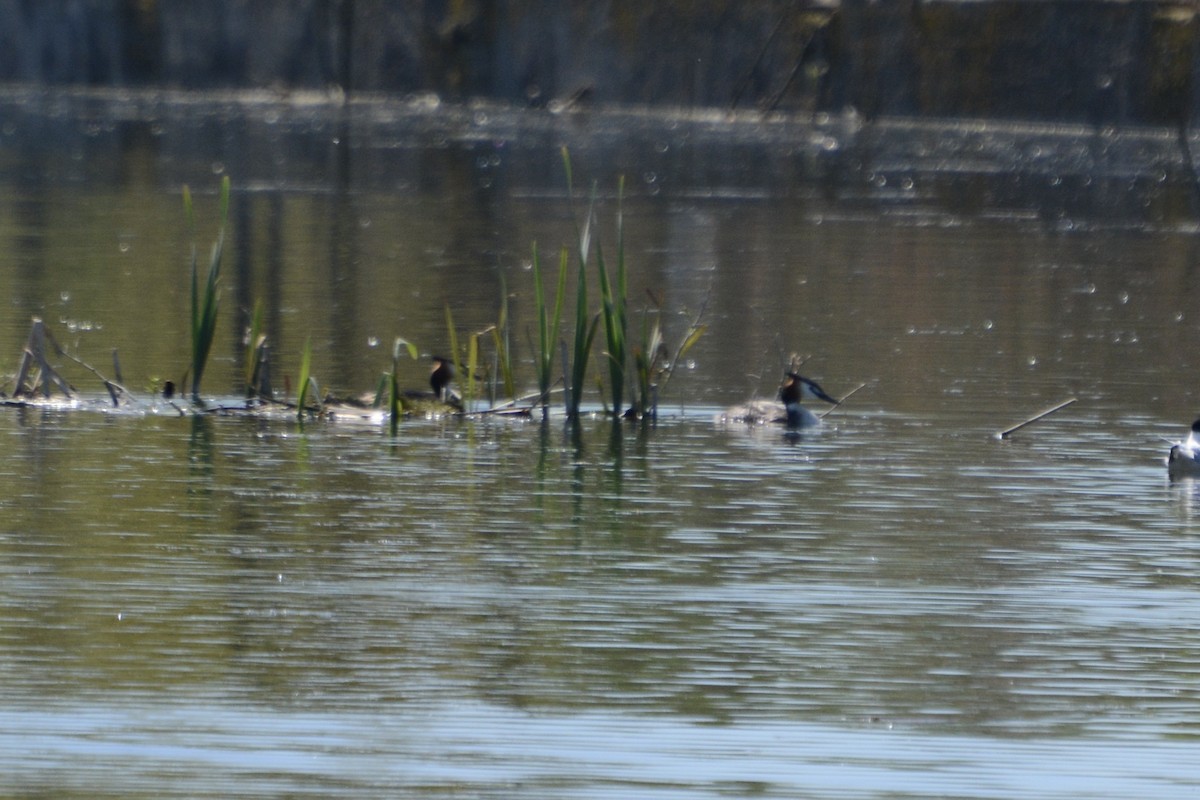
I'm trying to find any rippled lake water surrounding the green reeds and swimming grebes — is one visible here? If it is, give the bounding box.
[0,90,1200,800]
